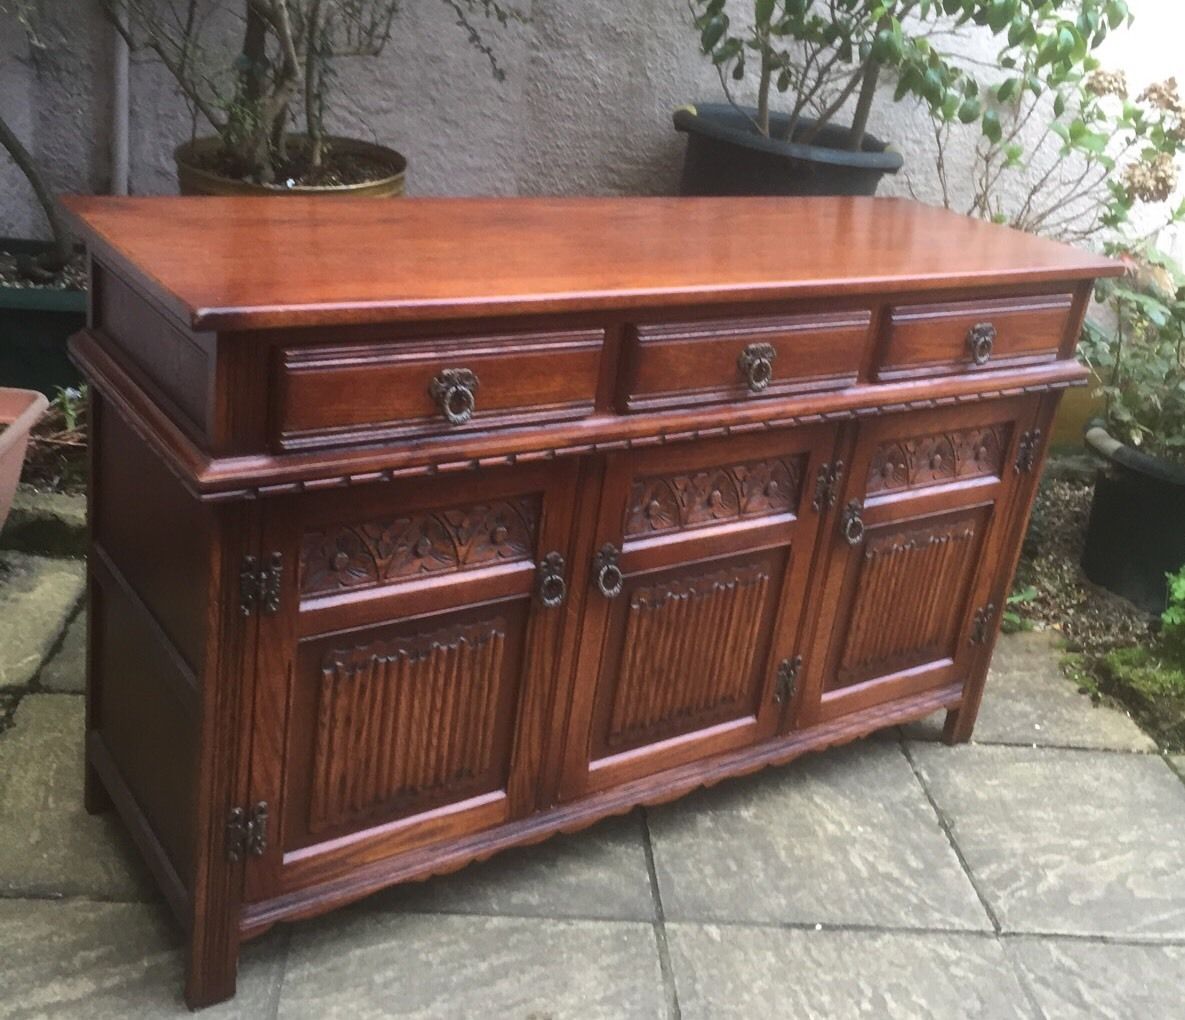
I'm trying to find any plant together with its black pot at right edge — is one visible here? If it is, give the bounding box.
[1082,248,1185,612]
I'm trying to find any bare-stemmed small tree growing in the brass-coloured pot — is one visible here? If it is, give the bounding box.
[100,0,523,184]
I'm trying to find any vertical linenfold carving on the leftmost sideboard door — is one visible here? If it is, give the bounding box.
[309,618,506,832]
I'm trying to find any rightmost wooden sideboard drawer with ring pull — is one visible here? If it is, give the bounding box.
[877,294,1074,380]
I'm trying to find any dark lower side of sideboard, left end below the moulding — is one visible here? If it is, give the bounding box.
[89,403,211,885]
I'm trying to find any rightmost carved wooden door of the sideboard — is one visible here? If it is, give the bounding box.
[800,398,1036,724]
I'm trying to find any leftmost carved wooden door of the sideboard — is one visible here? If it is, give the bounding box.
[246,461,577,899]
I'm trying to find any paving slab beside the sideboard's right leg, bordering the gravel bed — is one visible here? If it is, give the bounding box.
[903,633,1157,752]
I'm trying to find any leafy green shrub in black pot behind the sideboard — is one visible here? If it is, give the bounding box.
[674,0,1127,194]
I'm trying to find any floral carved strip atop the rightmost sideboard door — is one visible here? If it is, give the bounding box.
[867,425,1010,495]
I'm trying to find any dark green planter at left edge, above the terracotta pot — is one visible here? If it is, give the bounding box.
[0,238,87,397]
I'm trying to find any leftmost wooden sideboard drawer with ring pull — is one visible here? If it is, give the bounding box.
[273,329,604,449]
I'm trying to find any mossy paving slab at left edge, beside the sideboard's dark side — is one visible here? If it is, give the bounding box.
[0,694,154,900]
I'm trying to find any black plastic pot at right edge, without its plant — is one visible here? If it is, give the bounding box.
[1082,422,1185,612]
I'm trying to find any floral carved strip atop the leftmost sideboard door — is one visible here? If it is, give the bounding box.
[301,496,539,595]
